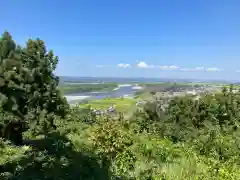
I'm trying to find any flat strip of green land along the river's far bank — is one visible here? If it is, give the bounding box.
[60,83,118,94]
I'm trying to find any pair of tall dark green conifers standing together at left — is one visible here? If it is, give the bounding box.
[0,32,68,145]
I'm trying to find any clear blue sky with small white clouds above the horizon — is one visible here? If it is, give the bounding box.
[0,0,240,79]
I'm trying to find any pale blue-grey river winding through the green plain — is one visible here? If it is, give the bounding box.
[65,84,142,104]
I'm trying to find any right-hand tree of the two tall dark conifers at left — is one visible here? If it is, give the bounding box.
[22,39,68,121]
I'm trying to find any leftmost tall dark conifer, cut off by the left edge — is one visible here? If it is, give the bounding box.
[0,32,28,144]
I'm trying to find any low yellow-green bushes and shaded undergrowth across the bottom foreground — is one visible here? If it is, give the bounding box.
[1,107,240,179]
